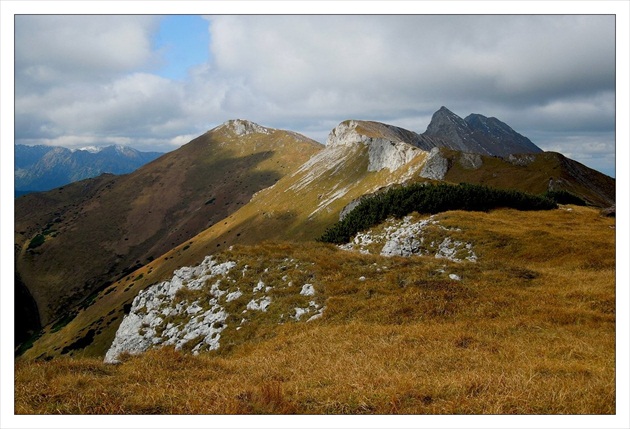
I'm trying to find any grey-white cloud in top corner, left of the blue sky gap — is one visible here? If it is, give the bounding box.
[15,15,159,89]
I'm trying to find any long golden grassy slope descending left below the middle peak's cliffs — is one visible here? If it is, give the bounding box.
[23,139,434,359]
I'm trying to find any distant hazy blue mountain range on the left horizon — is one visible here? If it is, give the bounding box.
[15,145,163,197]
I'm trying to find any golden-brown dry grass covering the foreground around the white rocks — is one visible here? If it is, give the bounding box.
[15,207,616,414]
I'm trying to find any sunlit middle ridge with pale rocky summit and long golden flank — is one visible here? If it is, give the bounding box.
[16,117,440,358]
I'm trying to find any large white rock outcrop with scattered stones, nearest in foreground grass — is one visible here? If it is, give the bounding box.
[104,256,323,363]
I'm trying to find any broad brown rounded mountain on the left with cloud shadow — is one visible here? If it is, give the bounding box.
[15,121,322,344]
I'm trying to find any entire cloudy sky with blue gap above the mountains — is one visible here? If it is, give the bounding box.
[14,15,616,177]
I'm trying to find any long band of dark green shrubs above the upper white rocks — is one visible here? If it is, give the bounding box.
[319,183,557,244]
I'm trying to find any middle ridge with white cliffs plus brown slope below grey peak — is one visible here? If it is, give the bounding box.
[18,113,614,358]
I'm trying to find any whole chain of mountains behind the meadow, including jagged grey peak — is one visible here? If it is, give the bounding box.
[15,107,615,358]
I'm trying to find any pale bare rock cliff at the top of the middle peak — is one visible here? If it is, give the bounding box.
[326,121,422,171]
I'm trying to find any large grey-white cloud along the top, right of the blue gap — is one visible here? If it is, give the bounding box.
[209,16,615,112]
